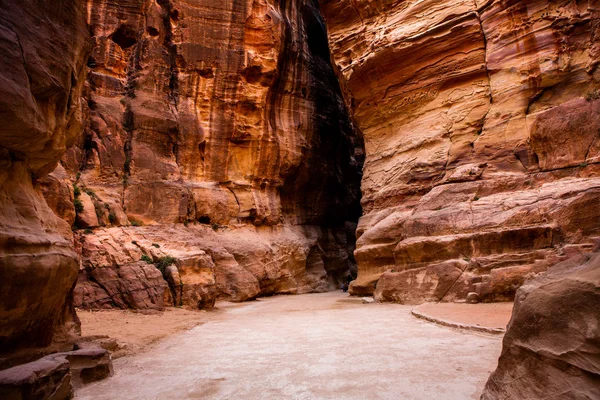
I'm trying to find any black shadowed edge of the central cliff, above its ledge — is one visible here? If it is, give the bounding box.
[278,1,364,227]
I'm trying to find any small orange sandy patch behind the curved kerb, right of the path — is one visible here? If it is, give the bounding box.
[411,303,513,335]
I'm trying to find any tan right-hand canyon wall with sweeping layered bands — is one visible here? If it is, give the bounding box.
[321,0,600,303]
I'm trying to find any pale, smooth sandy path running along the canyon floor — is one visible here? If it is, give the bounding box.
[76,292,501,400]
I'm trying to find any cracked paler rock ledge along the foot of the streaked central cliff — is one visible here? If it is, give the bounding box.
[74,224,348,309]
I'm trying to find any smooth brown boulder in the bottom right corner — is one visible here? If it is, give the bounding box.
[481,253,600,399]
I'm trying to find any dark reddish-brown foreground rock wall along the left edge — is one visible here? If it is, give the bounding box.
[0,0,89,353]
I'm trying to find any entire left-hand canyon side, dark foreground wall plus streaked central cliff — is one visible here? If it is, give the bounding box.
[0,0,363,354]
